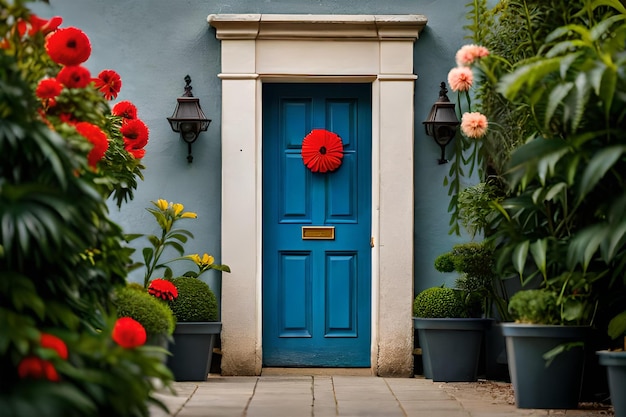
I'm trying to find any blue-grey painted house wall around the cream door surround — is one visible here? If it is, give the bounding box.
[33,0,467,300]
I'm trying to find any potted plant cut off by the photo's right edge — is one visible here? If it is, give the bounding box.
[596,311,626,417]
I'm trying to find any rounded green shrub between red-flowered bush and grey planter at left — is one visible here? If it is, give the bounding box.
[114,284,176,336]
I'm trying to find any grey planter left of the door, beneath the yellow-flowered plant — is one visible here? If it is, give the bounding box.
[167,322,222,381]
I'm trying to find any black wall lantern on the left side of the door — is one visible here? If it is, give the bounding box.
[167,75,211,163]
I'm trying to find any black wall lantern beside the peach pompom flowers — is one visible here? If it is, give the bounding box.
[423,82,460,164]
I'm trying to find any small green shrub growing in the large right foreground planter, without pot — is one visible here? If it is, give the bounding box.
[509,289,561,324]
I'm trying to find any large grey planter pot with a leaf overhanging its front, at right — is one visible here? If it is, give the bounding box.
[502,323,590,409]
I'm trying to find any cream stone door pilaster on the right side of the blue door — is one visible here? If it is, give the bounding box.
[377,75,415,377]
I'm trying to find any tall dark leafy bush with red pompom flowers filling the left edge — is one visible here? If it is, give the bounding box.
[0,0,172,417]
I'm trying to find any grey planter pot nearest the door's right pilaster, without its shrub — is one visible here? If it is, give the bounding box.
[413,317,493,382]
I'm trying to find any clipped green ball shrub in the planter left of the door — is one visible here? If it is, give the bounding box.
[169,277,217,322]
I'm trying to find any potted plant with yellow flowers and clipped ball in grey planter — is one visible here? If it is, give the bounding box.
[127,199,230,381]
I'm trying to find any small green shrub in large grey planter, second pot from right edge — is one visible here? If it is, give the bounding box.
[502,287,591,409]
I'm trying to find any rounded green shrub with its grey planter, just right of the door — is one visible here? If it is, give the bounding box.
[413,287,490,382]
